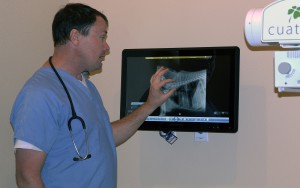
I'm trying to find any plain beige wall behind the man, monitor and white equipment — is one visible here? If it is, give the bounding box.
[0,0,300,188]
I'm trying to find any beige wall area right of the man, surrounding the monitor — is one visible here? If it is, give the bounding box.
[73,0,300,188]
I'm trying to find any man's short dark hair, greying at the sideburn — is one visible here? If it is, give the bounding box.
[52,3,108,46]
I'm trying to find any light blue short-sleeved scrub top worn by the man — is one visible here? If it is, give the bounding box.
[11,68,117,188]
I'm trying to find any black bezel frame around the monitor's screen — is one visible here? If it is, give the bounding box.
[120,46,240,133]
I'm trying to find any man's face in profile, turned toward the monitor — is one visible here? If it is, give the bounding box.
[80,16,109,72]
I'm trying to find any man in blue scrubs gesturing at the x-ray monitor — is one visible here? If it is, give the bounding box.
[11,4,175,188]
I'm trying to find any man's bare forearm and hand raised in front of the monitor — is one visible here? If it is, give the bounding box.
[112,67,176,146]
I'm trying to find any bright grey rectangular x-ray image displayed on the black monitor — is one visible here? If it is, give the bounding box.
[158,66,206,116]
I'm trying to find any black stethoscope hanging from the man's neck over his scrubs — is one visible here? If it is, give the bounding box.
[49,56,92,161]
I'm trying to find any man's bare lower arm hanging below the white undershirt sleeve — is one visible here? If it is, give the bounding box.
[15,148,46,188]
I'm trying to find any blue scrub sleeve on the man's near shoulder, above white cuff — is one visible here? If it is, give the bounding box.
[11,88,59,153]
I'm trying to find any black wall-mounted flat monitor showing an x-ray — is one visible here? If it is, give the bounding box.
[120,46,240,133]
